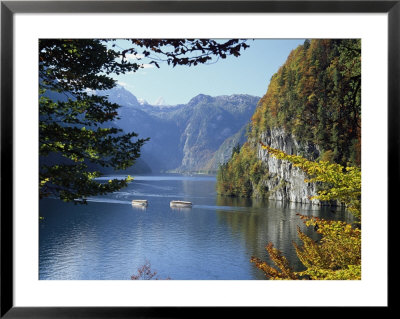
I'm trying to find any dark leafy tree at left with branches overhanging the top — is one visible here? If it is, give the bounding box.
[39,39,248,202]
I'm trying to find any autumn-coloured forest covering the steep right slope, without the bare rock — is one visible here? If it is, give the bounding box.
[217,39,361,197]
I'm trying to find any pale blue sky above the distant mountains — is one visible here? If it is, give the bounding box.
[108,39,304,105]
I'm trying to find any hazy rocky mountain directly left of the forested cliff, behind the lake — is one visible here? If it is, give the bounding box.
[171,95,259,171]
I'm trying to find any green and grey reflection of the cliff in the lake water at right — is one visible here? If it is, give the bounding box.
[217,196,350,279]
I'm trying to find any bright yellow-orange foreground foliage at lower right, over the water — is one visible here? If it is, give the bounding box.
[251,144,361,280]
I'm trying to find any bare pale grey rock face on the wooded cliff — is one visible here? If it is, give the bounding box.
[257,128,320,204]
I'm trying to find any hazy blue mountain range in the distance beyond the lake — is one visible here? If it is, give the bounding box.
[100,86,259,173]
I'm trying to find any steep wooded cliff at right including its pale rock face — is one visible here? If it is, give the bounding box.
[217,39,361,203]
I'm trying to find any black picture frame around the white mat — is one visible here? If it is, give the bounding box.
[0,0,394,318]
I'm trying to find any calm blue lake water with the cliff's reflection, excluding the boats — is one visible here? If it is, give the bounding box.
[39,175,348,280]
